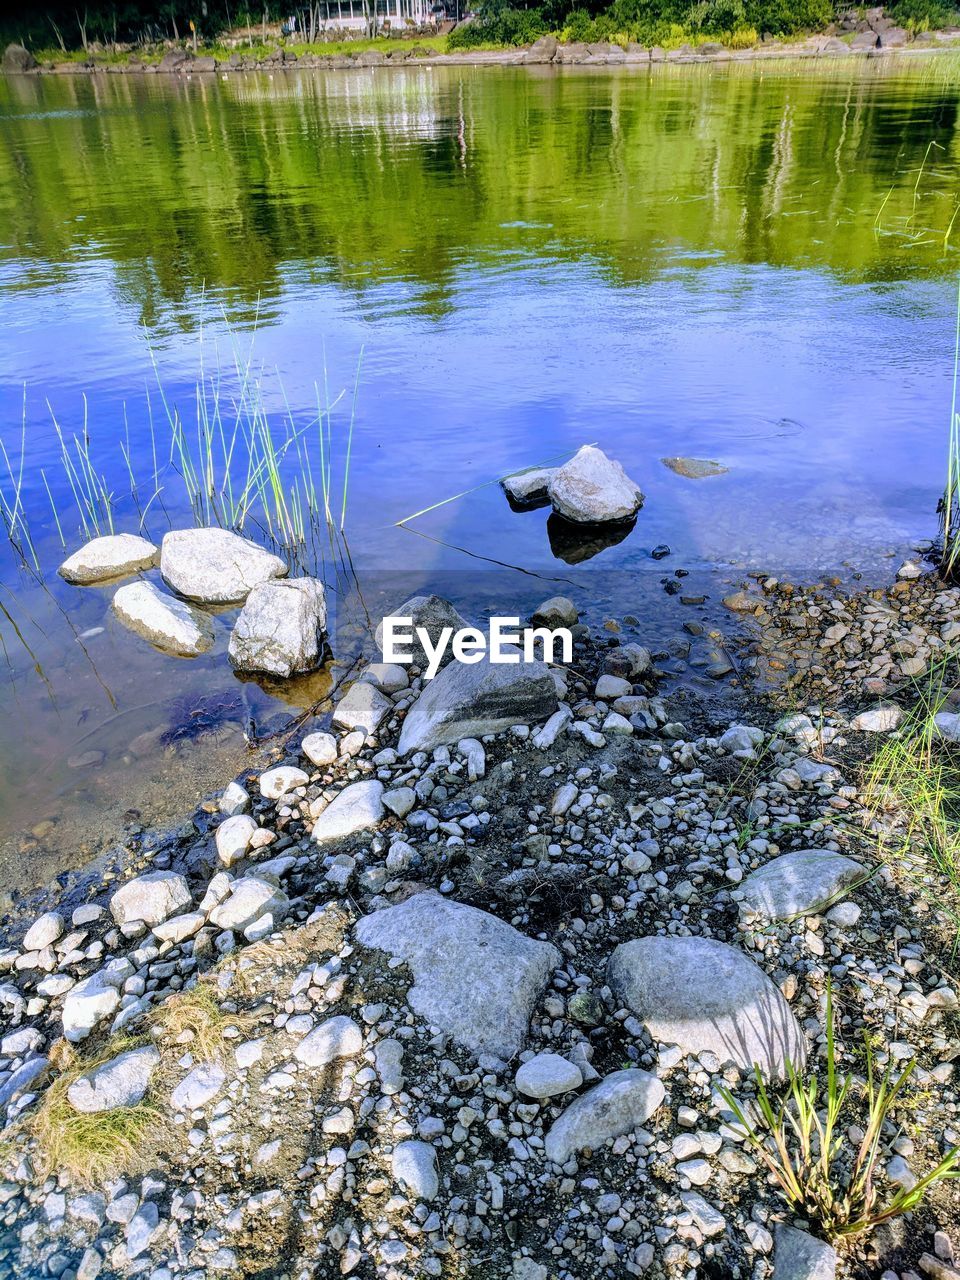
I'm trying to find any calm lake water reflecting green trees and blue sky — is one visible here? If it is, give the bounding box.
[0,55,960,887]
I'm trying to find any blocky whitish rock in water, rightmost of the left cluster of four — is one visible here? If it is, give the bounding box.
[227,577,326,680]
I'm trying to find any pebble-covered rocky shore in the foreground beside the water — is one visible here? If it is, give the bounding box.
[0,566,960,1280]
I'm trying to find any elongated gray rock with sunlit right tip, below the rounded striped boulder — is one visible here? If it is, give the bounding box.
[544,1068,667,1165]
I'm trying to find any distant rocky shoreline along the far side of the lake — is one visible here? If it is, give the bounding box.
[0,22,960,77]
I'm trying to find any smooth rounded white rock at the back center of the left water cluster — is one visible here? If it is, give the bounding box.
[160,529,287,604]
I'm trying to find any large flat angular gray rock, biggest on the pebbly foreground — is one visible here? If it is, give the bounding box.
[355,891,561,1059]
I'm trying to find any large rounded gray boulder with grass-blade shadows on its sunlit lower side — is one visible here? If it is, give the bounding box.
[607,937,806,1076]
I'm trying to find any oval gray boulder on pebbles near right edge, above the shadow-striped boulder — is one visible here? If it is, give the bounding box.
[732,849,868,920]
